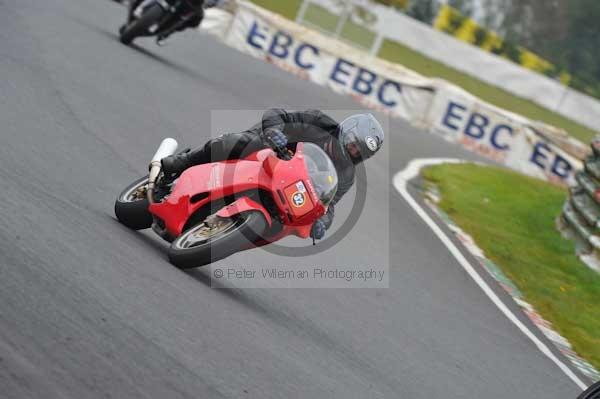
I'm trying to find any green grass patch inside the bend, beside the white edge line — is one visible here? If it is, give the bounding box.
[423,164,600,369]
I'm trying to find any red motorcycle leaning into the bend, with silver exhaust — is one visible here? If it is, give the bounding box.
[115,139,338,268]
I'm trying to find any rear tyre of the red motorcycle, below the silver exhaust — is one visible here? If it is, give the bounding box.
[115,176,153,230]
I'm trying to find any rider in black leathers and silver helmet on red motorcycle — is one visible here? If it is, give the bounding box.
[162,109,384,239]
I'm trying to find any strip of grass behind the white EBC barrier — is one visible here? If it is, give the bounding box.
[247,0,596,143]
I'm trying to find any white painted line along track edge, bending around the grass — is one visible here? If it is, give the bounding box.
[393,158,587,390]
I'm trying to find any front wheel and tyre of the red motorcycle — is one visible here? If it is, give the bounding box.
[169,211,267,269]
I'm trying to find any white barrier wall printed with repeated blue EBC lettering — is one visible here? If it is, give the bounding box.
[202,2,581,184]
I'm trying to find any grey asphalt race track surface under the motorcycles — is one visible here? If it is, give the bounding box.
[0,0,592,399]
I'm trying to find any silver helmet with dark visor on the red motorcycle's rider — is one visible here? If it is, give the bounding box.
[338,114,385,163]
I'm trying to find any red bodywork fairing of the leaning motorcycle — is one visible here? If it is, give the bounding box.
[149,143,330,242]
